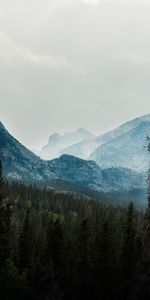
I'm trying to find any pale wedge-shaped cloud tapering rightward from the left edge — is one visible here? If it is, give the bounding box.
[0,32,72,70]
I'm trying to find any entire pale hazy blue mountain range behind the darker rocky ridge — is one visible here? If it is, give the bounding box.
[39,114,150,172]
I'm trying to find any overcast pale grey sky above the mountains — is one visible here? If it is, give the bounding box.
[0,0,150,149]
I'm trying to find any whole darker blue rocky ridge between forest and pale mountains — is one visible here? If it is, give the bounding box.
[0,123,145,193]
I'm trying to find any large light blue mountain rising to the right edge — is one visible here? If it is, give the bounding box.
[89,115,150,172]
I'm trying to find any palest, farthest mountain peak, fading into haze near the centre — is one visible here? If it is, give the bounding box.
[40,128,95,160]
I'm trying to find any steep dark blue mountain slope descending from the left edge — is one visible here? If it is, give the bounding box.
[0,123,53,182]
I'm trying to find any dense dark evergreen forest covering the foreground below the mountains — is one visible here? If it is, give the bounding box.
[0,165,150,300]
